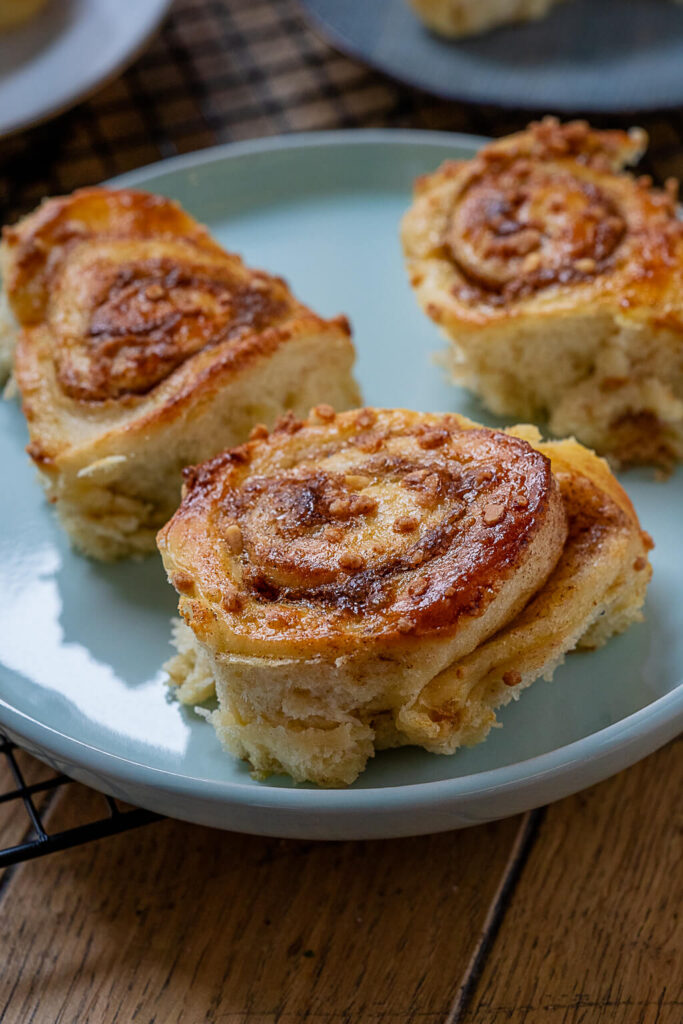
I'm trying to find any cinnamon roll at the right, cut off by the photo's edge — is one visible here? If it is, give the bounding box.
[402,119,683,465]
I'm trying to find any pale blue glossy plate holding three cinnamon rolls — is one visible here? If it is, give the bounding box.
[0,131,683,839]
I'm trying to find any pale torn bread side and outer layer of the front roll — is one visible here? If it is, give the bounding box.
[161,411,650,786]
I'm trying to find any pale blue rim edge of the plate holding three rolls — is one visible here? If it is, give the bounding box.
[0,128,683,827]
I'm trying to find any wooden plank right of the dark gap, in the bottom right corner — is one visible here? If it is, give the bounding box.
[454,739,683,1024]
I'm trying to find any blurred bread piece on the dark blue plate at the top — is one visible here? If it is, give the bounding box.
[410,0,561,39]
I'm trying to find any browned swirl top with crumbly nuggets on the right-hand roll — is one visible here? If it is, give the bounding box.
[443,119,681,305]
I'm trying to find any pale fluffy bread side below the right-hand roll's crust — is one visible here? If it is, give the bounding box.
[444,301,683,466]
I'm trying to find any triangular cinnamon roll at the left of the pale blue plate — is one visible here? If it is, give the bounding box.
[2,188,358,559]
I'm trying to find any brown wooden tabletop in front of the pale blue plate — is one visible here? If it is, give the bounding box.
[0,740,683,1024]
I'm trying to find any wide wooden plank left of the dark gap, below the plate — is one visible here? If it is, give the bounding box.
[0,787,521,1024]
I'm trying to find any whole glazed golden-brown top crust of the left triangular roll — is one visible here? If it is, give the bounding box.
[3,188,301,401]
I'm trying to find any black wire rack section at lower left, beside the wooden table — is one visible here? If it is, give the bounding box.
[0,733,161,868]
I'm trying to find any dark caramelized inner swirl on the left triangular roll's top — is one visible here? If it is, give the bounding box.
[54,249,290,400]
